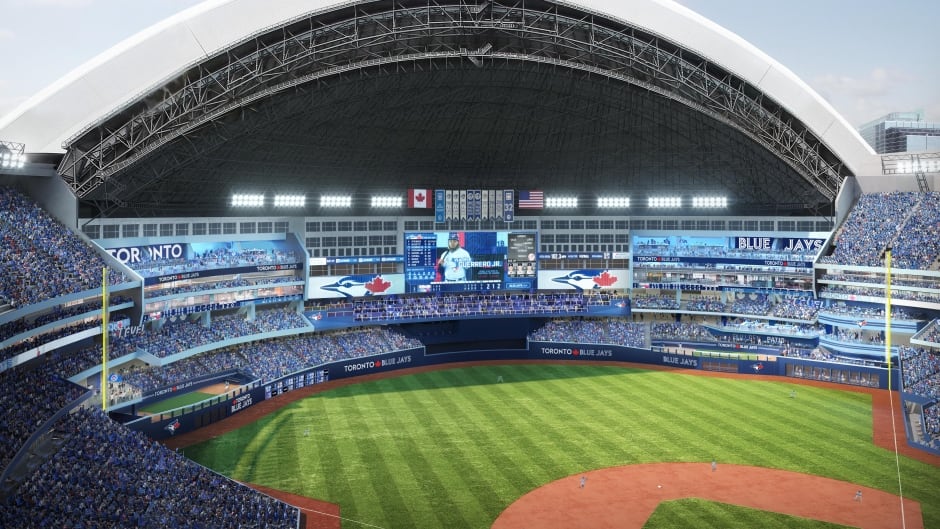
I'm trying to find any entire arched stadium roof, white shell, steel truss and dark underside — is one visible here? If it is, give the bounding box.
[0,0,873,217]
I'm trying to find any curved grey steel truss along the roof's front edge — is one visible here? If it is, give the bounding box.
[59,0,847,200]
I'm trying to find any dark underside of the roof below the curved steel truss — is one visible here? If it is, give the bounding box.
[81,61,829,217]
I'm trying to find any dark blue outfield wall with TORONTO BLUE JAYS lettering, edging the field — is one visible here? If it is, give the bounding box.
[129,341,898,440]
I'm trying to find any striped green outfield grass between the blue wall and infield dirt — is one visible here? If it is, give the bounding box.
[185,364,940,529]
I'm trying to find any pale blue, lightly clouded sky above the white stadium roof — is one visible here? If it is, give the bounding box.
[0,0,940,126]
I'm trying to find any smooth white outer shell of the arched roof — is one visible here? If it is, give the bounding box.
[0,0,875,171]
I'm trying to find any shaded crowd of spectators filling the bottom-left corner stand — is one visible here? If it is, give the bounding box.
[0,408,300,529]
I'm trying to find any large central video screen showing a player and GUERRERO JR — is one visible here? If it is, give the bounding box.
[405,231,538,293]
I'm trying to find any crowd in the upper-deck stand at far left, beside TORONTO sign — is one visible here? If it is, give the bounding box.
[0,186,128,308]
